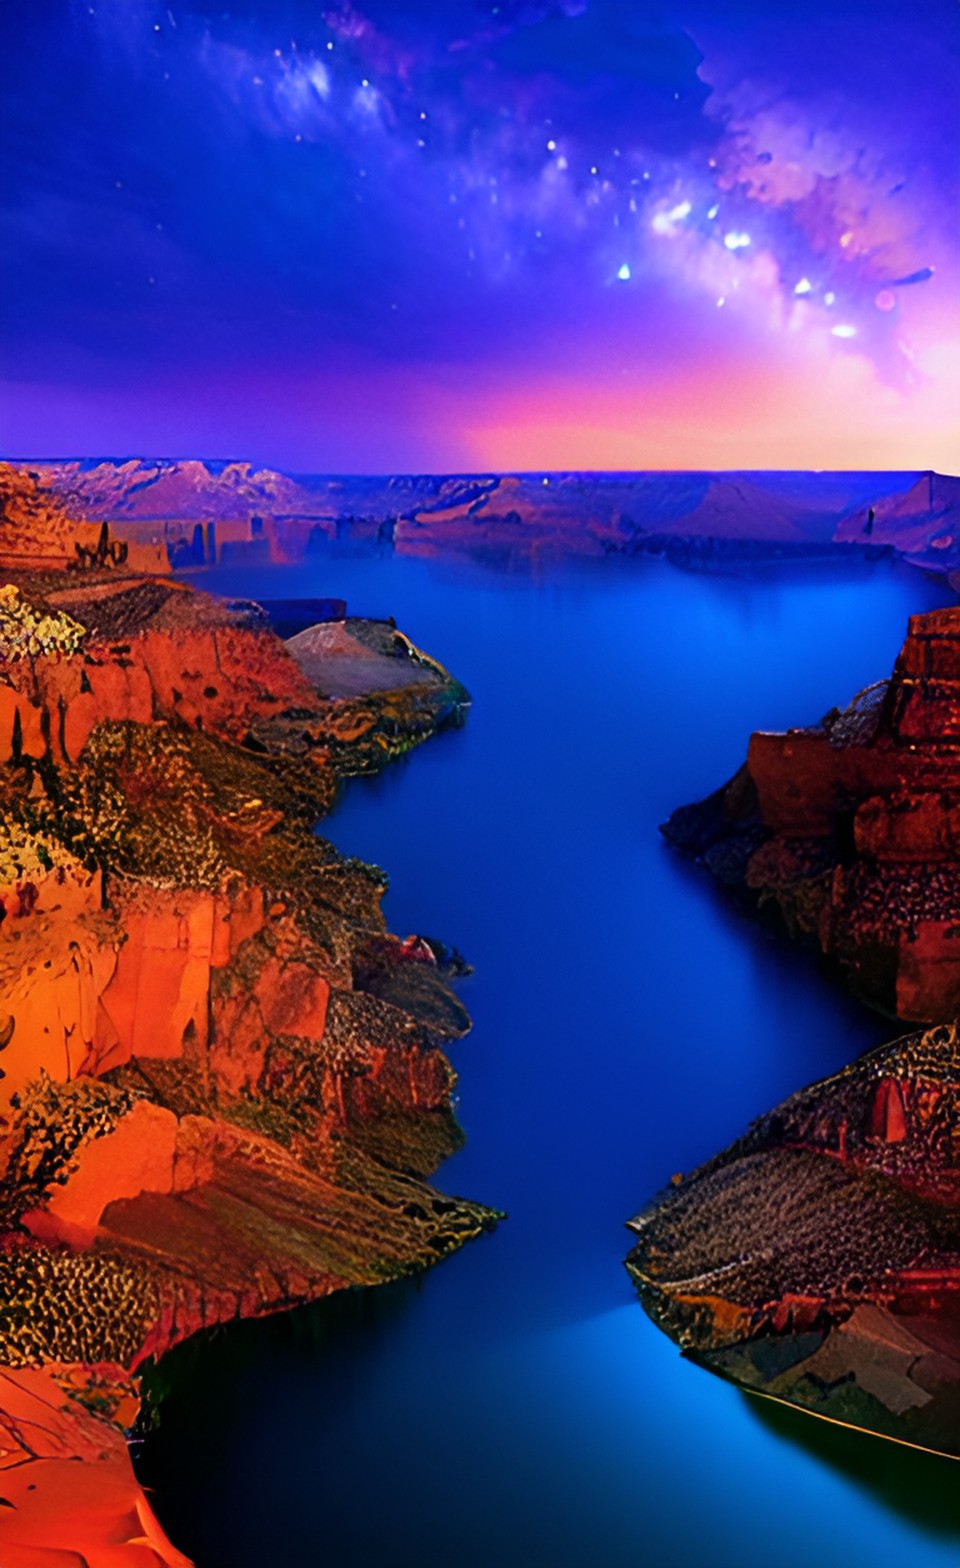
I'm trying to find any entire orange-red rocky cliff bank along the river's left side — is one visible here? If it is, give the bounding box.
[0,539,496,1568]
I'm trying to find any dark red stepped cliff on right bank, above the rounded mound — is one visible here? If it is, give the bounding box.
[662,608,960,1024]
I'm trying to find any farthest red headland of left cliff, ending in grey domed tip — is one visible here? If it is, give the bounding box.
[0,569,469,777]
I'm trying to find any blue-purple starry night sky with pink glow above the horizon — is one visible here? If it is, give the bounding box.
[0,0,960,472]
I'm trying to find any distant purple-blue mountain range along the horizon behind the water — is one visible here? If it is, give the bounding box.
[1,458,960,574]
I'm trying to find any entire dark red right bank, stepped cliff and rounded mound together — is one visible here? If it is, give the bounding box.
[627,608,960,1457]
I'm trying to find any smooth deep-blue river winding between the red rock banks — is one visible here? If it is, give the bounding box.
[138,557,960,1568]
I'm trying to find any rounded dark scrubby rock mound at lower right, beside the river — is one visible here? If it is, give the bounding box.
[627,1025,960,1457]
